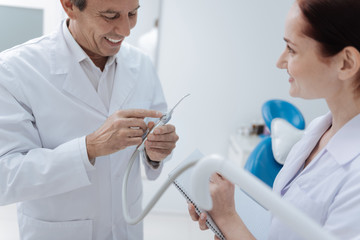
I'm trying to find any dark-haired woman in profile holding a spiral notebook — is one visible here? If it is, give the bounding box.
[189,0,360,240]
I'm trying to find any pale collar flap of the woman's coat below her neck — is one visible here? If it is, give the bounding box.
[326,114,360,165]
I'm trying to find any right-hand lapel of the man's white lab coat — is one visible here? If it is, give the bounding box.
[109,54,138,114]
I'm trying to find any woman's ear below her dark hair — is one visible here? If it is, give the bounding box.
[339,47,360,80]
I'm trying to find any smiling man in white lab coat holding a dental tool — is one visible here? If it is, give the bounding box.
[0,0,178,240]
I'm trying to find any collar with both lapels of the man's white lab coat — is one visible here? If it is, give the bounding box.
[50,20,140,116]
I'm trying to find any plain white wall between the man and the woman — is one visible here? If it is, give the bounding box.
[148,0,327,213]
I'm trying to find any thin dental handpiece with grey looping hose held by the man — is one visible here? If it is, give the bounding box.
[122,94,191,224]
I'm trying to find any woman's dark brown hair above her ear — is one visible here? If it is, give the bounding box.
[297,0,360,57]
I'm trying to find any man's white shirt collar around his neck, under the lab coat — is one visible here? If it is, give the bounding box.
[63,19,116,66]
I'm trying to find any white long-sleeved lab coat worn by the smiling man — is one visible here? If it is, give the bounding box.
[0,21,166,240]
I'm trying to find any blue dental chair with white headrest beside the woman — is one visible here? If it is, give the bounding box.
[244,99,305,187]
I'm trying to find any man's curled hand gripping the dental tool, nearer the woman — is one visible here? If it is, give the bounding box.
[145,122,179,162]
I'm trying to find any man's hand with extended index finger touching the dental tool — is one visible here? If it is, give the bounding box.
[86,109,162,159]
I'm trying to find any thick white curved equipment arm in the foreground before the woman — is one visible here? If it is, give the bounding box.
[191,155,337,240]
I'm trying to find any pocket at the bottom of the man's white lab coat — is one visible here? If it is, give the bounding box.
[19,215,92,240]
